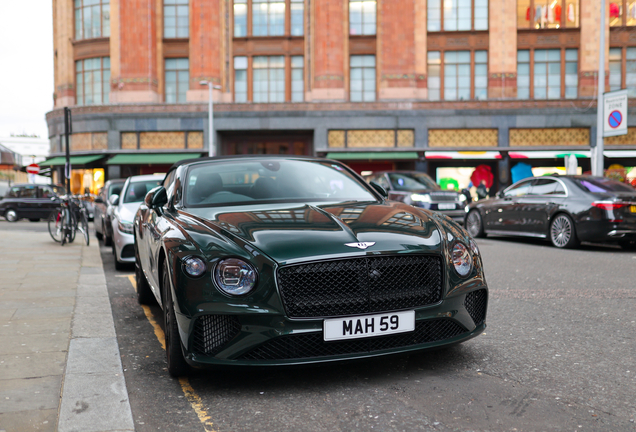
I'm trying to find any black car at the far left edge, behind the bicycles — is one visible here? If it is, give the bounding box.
[0,183,66,222]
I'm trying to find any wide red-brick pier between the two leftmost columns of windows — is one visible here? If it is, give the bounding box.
[110,0,161,103]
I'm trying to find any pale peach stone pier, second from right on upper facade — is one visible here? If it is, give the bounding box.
[488,0,517,99]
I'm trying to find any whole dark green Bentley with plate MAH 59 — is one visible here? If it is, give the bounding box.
[134,156,488,376]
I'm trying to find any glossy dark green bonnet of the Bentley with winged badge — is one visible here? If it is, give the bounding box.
[188,203,442,264]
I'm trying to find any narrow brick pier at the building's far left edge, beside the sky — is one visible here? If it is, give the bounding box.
[53,0,75,108]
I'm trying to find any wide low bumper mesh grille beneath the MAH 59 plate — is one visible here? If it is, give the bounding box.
[240,319,466,360]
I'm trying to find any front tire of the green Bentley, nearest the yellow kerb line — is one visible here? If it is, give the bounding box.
[161,261,190,378]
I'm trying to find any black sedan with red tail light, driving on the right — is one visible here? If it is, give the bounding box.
[466,176,636,249]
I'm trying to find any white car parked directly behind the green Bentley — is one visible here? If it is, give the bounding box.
[109,174,165,270]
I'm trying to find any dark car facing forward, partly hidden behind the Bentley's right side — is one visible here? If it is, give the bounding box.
[365,171,467,224]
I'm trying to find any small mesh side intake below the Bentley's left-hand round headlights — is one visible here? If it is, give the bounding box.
[192,315,241,355]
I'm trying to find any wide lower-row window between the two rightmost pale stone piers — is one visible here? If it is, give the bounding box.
[517,49,579,99]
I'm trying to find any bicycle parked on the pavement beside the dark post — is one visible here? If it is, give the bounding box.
[48,195,90,246]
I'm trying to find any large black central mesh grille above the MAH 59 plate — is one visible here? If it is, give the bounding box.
[278,255,442,318]
